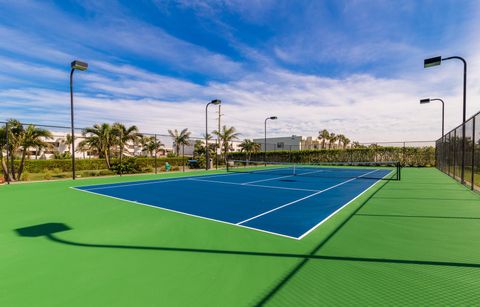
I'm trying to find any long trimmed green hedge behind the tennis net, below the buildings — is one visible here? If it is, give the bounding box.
[228,147,435,166]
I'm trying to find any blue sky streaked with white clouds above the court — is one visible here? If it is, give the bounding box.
[0,0,480,142]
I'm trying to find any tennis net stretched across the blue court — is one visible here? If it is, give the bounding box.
[227,160,401,180]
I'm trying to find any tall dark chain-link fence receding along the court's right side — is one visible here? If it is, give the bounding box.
[436,112,480,190]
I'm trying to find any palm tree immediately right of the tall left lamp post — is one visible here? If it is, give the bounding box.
[82,123,115,169]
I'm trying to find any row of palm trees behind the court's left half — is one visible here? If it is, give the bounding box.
[0,119,246,181]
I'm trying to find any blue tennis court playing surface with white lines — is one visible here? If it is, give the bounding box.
[76,168,391,239]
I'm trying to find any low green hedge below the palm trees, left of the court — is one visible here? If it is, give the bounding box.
[3,157,188,173]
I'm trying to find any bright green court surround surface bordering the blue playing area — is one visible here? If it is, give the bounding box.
[0,168,480,306]
